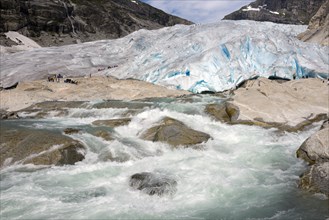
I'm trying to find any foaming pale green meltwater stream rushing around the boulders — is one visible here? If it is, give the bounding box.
[0,96,329,219]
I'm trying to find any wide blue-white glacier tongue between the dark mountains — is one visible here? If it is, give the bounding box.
[0,21,329,93]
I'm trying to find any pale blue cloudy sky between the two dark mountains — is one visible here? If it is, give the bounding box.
[141,0,254,23]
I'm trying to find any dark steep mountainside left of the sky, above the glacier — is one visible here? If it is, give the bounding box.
[0,0,191,46]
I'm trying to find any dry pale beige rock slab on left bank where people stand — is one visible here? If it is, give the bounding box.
[0,76,190,111]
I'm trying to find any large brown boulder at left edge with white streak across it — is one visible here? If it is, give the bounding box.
[0,125,86,166]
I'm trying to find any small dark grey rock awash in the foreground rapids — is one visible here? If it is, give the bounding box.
[129,172,177,196]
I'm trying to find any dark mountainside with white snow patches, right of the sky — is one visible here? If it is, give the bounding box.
[224,0,326,24]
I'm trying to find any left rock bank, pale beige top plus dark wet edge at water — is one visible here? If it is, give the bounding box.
[0,76,190,111]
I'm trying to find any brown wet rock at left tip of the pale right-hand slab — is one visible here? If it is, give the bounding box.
[205,102,239,123]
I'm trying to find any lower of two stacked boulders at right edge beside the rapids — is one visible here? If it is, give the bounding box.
[299,162,329,197]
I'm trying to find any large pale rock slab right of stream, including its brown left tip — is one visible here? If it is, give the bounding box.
[206,78,329,131]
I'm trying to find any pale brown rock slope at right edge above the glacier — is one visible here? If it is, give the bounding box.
[298,0,329,46]
